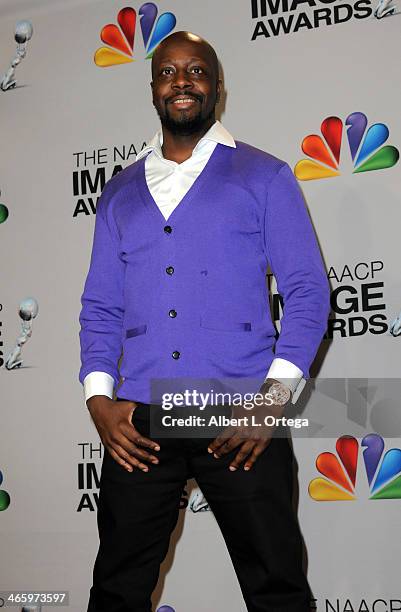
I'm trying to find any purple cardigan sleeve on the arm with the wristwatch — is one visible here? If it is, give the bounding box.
[264,162,330,378]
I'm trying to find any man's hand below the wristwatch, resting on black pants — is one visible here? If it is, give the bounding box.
[208,379,285,471]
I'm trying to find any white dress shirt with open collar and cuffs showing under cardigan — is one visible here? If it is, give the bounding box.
[84,120,306,403]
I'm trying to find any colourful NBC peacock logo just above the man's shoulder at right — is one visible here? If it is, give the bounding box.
[294,113,400,181]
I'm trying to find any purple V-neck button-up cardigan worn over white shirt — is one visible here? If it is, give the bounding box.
[79,141,330,403]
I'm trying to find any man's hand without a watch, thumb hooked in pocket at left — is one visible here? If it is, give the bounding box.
[86,395,160,472]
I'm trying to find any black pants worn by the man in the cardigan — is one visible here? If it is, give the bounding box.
[88,404,310,612]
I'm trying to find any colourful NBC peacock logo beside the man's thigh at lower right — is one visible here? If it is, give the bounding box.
[309,434,401,501]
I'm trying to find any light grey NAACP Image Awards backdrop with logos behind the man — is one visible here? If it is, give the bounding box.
[0,0,401,612]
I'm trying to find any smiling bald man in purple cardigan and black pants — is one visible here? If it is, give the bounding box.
[79,32,329,612]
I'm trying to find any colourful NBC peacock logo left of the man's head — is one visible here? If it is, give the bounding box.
[94,2,177,68]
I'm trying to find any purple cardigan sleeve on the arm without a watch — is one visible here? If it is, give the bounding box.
[79,181,125,385]
